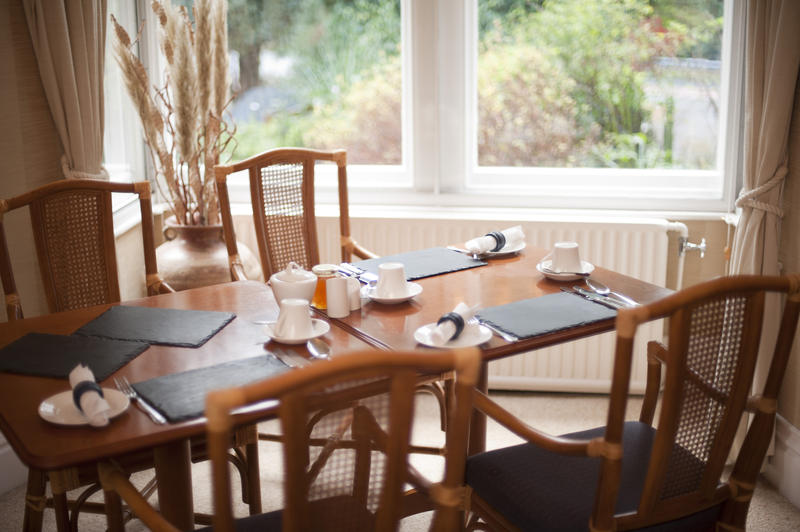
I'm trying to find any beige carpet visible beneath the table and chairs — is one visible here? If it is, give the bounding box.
[0,392,800,532]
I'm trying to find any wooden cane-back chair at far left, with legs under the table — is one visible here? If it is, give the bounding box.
[0,179,260,530]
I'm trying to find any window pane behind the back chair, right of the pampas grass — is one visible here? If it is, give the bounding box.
[228,0,402,164]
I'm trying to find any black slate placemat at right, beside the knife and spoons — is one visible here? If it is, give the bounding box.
[477,293,617,338]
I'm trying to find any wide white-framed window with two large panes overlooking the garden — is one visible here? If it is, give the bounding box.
[107,0,744,211]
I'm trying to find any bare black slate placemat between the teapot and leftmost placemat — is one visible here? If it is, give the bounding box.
[75,305,236,347]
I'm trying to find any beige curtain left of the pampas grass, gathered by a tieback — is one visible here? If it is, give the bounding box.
[22,0,108,179]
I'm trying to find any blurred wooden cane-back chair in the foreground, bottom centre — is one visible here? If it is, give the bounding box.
[100,348,481,532]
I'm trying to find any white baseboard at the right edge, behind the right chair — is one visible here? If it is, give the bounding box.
[764,416,800,508]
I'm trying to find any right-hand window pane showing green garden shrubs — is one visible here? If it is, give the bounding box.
[477,0,724,170]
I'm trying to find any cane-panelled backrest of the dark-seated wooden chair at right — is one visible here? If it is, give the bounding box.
[592,275,800,530]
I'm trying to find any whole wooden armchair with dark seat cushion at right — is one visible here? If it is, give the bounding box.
[466,275,800,531]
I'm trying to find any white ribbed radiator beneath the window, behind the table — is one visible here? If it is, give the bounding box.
[310,216,670,393]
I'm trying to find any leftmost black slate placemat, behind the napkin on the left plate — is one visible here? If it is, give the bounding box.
[0,333,150,381]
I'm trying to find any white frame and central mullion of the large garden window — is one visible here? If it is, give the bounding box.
[125,0,745,213]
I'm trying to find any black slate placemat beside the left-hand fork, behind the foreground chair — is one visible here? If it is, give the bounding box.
[133,355,289,422]
